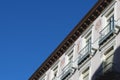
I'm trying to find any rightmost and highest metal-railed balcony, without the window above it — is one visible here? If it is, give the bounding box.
[99,21,115,45]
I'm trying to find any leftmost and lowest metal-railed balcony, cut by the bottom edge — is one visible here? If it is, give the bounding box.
[60,61,74,80]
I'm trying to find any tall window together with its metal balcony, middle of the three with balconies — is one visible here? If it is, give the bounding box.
[77,27,92,65]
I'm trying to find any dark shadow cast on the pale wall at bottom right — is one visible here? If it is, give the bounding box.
[91,46,120,80]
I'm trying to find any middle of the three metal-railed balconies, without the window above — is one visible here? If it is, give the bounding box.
[78,43,91,65]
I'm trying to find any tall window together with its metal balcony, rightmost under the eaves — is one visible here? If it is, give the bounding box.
[99,9,114,45]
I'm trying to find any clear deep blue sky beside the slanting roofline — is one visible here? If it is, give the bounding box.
[0,0,97,80]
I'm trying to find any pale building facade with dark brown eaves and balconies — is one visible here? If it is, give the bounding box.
[29,0,120,80]
